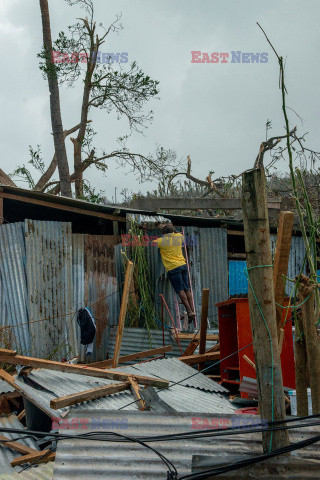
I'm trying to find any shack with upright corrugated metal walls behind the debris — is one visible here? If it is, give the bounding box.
[0,186,305,361]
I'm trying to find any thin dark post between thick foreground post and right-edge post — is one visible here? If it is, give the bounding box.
[294,312,309,417]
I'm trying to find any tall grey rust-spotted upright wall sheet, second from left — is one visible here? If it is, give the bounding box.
[25,220,78,359]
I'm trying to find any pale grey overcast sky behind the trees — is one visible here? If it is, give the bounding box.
[0,0,320,200]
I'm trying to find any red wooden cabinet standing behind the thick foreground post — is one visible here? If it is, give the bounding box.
[216,298,295,396]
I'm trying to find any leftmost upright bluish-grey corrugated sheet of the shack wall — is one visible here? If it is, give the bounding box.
[0,223,30,355]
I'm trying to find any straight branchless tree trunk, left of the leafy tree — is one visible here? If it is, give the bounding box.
[40,0,72,197]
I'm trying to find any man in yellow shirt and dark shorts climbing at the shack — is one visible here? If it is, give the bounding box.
[155,223,195,324]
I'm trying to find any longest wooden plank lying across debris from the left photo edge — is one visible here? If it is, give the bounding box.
[0,354,169,390]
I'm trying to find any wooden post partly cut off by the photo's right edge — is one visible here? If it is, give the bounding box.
[298,275,320,414]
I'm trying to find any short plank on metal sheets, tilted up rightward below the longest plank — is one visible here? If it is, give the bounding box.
[50,381,131,410]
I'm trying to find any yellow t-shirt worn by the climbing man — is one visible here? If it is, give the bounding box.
[155,233,186,272]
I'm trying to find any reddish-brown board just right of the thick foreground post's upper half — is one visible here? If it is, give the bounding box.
[273,212,294,338]
